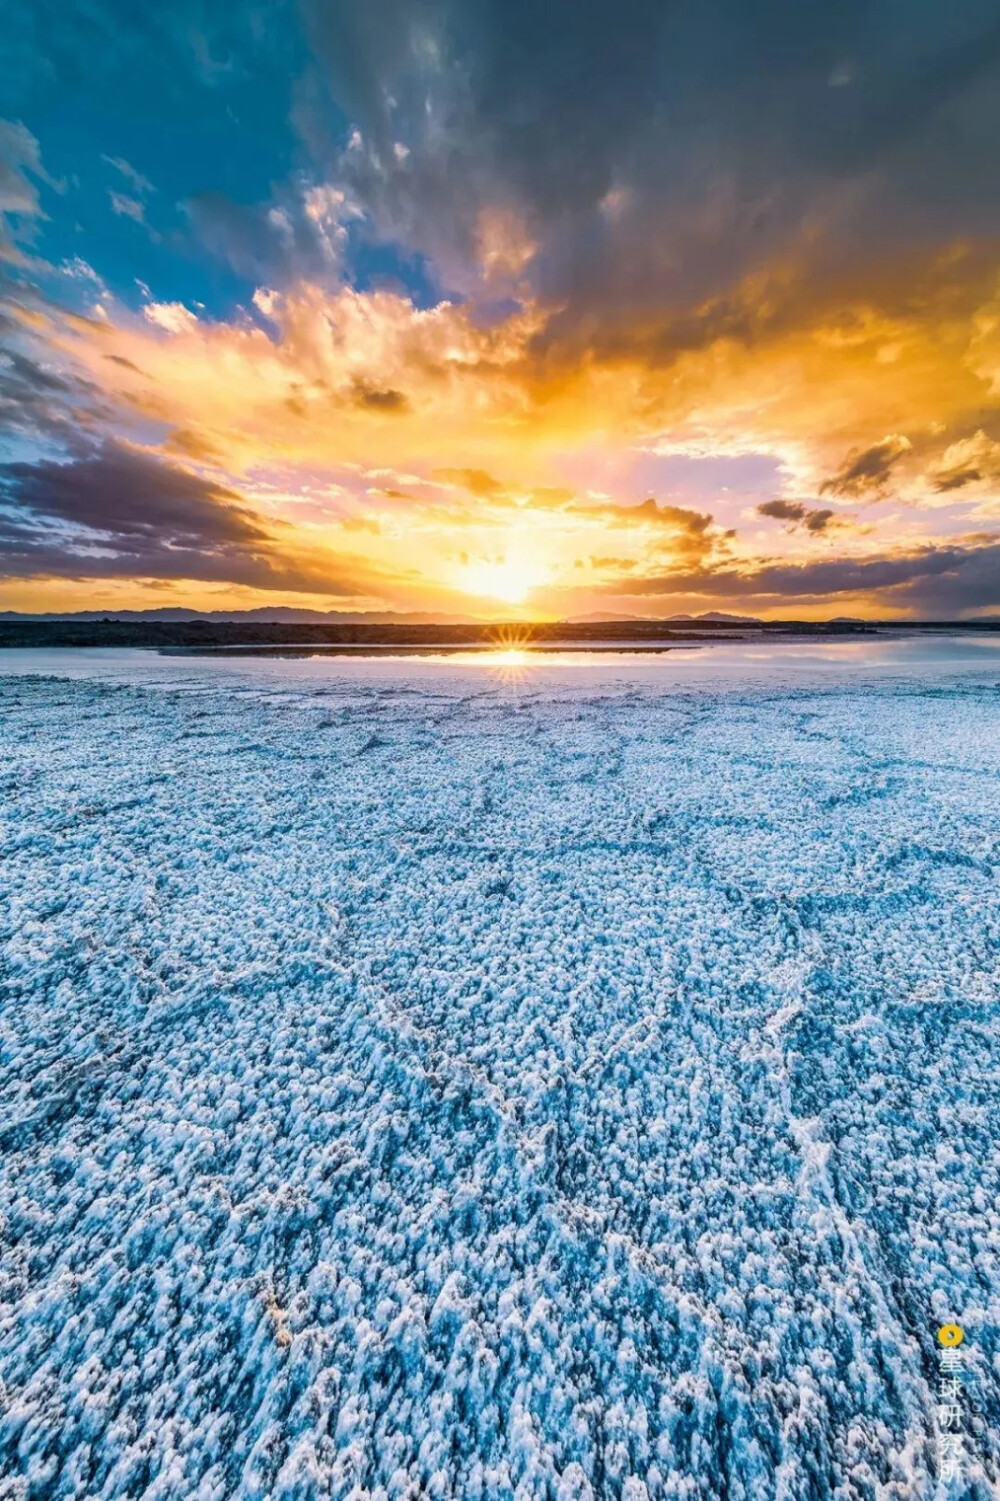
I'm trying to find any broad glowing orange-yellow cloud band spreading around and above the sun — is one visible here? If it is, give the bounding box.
[7,228,1000,609]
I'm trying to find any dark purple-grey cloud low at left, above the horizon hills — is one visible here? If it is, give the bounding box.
[0,443,357,594]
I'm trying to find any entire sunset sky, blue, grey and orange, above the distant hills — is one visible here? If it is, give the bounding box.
[0,0,1000,618]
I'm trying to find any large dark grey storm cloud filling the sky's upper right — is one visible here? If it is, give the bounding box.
[306,0,1000,344]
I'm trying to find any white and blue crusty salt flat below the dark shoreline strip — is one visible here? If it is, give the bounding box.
[0,648,1000,1501]
